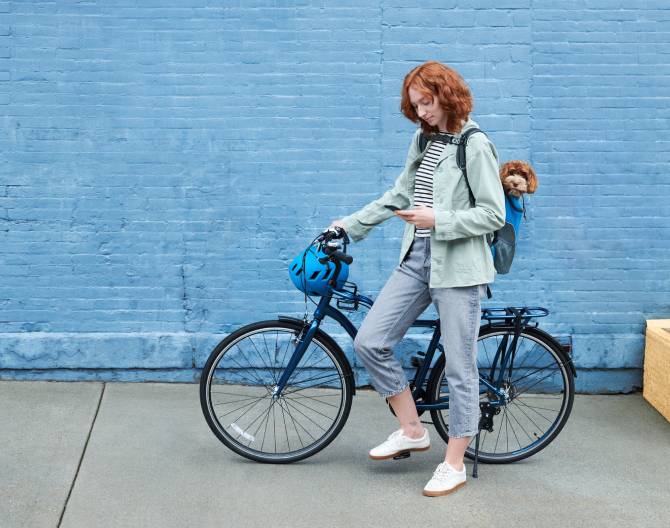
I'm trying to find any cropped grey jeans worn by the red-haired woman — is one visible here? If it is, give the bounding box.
[354,236,486,438]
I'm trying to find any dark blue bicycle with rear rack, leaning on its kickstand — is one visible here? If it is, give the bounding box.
[200,228,577,477]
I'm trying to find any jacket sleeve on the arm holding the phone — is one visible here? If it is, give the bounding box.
[435,137,505,240]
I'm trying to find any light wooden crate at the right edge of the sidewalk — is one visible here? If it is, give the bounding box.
[642,319,670,421]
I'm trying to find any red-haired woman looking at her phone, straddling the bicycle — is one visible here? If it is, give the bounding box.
[331,62,505,496]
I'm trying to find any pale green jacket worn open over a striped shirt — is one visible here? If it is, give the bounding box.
[342,119,505,288]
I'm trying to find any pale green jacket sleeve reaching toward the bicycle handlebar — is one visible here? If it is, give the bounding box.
[342,129,421,242]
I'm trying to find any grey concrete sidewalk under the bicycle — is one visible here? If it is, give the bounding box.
[0,381,670,528]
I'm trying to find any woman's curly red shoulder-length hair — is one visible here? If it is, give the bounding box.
[400,61,474,135]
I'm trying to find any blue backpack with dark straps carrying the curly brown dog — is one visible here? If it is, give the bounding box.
[419,128,526,275]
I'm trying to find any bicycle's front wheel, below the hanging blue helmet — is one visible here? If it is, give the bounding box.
[200,321,354,464]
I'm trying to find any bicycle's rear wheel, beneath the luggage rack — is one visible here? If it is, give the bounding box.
[428,326,575,464]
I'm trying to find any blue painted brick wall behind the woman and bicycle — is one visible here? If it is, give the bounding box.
[0,0,670,391]
